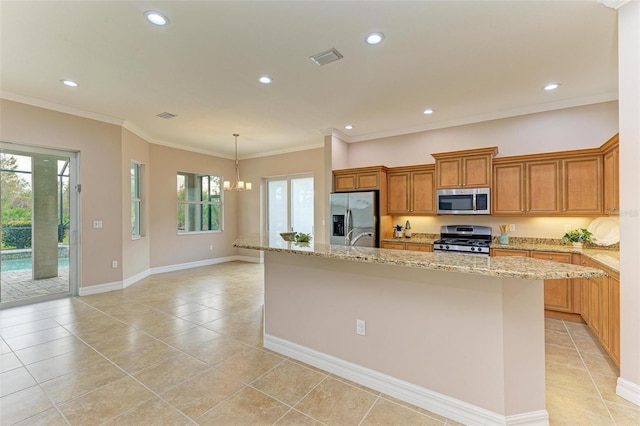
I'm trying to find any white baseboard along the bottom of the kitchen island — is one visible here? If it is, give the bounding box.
[264,334,549,425]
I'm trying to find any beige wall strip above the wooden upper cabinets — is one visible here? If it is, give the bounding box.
[348,102,618,169]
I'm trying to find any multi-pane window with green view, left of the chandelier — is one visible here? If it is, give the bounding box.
[178,172,222,234]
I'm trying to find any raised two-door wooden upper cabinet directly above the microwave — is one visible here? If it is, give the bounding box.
[431,147,498,188]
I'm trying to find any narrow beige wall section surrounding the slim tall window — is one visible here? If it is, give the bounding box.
[122,128,153,279]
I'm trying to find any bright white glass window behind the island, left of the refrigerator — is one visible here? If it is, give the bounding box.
[266,176,313,238]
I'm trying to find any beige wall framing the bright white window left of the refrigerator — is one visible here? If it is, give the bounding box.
[237,146,328,257]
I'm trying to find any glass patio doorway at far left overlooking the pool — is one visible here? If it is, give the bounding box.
[0,142,78,308]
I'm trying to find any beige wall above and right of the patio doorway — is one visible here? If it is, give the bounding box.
[0,99,122,287]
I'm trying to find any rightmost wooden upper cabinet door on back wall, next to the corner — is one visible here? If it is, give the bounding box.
[562,155,603,215]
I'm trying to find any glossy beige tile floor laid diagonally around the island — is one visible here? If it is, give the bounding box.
[0,262,640,426]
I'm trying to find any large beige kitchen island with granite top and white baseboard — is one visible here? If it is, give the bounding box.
[234,237,604,424]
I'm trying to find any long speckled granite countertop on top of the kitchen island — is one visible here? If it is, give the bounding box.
[233,236,605,280]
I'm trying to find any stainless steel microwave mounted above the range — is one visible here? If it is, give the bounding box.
[436,188,491,214]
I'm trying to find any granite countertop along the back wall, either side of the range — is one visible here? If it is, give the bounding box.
[381,234,620,273]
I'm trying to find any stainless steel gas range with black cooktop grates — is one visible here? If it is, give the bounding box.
[433,225,491,256]
